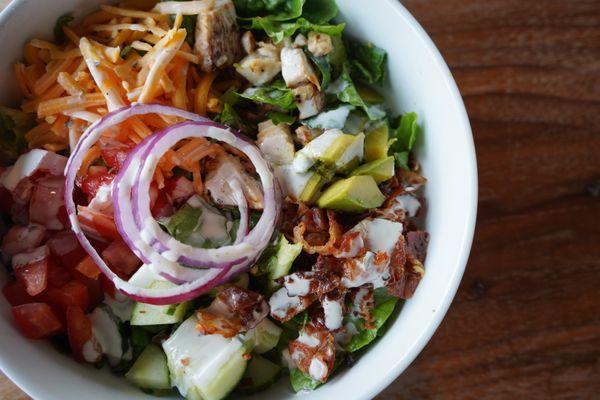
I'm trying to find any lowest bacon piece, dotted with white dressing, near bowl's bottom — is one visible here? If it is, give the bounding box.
[288,324,335,382]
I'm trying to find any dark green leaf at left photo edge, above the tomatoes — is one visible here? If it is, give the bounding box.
[0,107,35,165]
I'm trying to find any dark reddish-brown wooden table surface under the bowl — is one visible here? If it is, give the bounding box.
[0,0,600,400]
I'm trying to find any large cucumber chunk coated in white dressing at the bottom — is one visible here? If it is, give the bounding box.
[163,316,247,400]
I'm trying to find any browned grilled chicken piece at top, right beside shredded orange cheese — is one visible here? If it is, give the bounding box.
[195,0,242,72]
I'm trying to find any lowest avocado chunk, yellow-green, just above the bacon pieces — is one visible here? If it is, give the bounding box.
[317,175,385,213]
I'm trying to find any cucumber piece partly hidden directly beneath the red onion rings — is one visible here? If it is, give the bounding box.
[131,281,189,326]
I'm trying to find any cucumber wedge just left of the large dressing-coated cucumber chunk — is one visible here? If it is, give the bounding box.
[125,344,171,390]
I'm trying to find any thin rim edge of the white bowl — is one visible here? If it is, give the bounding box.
[0,0,478,399]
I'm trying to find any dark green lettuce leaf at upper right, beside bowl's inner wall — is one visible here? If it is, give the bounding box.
[348,41,387,84]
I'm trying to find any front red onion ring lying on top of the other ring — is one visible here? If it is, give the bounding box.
[128,122,280,268]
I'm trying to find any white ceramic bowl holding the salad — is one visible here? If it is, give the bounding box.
[0,0,477,400]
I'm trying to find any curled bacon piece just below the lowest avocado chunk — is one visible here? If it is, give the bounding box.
[294,207,342,255]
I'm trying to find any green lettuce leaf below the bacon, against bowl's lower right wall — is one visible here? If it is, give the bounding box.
[345,288,398,353]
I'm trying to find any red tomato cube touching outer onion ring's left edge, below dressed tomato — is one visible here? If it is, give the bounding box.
[29,177,68,230]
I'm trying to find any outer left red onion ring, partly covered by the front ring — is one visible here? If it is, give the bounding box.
[65,104,234,305]
